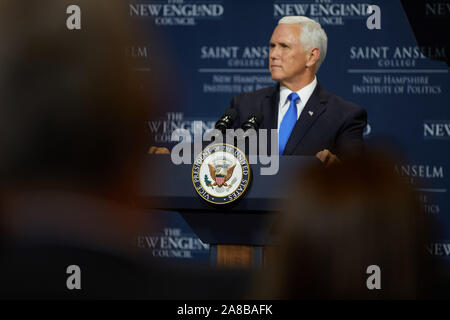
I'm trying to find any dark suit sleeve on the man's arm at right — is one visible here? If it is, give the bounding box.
[336,107,367,158]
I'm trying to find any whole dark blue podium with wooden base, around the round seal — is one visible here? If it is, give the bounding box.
[138,155,319,267]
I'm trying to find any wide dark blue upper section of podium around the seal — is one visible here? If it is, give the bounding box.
[139,155,319,212]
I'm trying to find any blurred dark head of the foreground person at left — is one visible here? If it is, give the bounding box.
[0,0,152,200]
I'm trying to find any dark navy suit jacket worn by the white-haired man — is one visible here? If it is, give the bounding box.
[231,83,367,157]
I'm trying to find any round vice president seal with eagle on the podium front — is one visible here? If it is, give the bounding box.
[192,143,250,204]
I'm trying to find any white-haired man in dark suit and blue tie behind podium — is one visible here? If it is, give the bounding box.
[231,16,367,165]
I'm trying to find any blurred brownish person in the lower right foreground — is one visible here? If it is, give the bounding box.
[252,151,439,299]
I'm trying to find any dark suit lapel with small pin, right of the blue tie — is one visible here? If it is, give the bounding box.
[284,83,326,155]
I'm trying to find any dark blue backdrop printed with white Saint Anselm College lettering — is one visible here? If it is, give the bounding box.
[128,0,450,262]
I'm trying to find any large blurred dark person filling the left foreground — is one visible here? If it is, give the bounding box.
[0,0,160,298]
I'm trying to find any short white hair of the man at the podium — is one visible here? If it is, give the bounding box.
[278,16,328,72]
